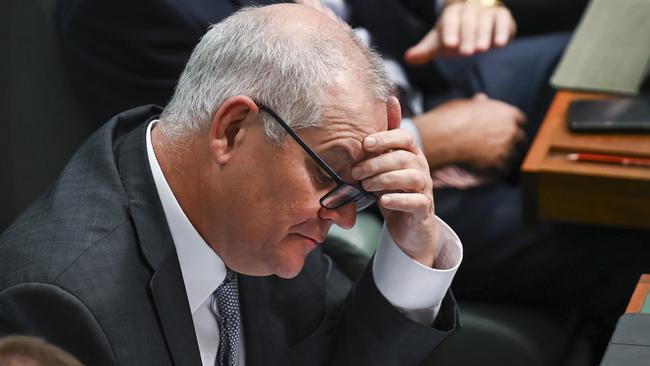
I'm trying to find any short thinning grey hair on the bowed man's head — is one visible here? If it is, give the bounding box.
[160,7,394,142]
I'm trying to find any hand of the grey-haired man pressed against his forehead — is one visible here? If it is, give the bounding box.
[352,98,436,267]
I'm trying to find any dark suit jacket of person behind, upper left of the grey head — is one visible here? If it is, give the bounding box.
[56,0,282,126]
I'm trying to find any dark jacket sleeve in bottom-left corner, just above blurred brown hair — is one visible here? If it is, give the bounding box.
[0,282,115,366]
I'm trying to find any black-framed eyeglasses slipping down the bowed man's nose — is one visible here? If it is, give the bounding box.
[258,103,377,211]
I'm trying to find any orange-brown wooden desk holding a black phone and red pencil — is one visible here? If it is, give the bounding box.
[522,91,650,228]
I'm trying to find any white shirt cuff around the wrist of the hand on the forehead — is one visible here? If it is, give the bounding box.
[372,216,463,325]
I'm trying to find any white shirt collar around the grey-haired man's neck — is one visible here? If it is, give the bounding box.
[147,120,226,314]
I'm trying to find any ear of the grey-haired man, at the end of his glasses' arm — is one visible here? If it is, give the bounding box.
[209,95,258,164]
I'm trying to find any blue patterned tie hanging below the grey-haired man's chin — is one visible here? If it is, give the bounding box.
[212,269,239,366]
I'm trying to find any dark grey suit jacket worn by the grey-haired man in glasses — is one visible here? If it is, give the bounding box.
[0,106,457,366]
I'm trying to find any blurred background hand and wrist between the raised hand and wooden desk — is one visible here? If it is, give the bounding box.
[413,93,526,170]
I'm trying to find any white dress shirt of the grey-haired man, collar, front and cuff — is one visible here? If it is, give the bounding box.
[146,121,463,366]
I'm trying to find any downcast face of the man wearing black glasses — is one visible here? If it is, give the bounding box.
[217,96,387,278]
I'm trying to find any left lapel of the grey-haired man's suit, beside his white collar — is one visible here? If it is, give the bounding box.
[116,106,201,366]
